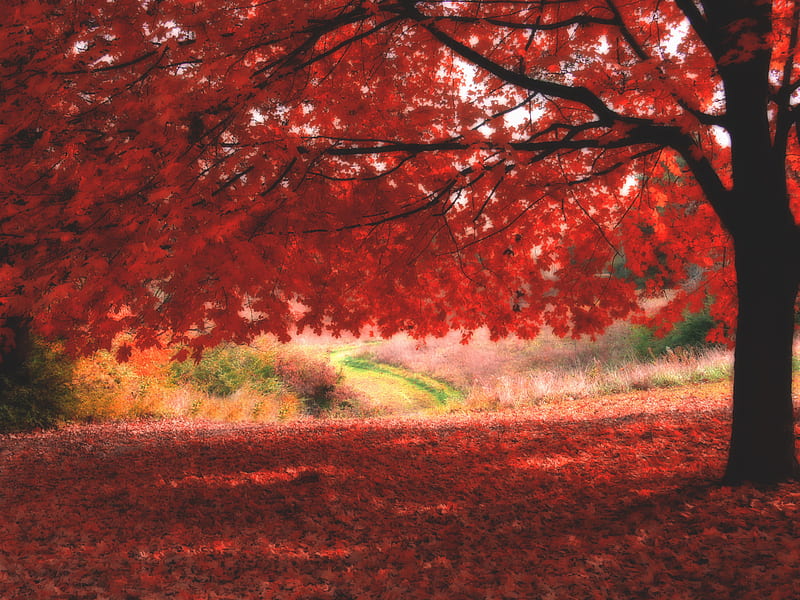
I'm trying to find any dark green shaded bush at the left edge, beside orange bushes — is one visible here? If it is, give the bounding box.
[0,340,76,431]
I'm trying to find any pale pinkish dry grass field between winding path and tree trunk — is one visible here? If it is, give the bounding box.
[368,323,733,410]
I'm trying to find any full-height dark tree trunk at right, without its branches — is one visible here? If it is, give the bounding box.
[704,0,800,484]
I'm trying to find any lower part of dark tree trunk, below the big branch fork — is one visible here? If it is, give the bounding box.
[725,232,800,484]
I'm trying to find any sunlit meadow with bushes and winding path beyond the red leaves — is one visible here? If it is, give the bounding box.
[42,310,744,422]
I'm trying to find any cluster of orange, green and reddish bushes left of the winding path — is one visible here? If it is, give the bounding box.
[74,339,361,421]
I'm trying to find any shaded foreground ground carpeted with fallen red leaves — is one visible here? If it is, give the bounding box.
[0,385,800,600]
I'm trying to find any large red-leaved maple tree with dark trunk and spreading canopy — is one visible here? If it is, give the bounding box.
[0,0,800,482]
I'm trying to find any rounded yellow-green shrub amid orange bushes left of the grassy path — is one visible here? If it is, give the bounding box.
[170,345,281,397]
